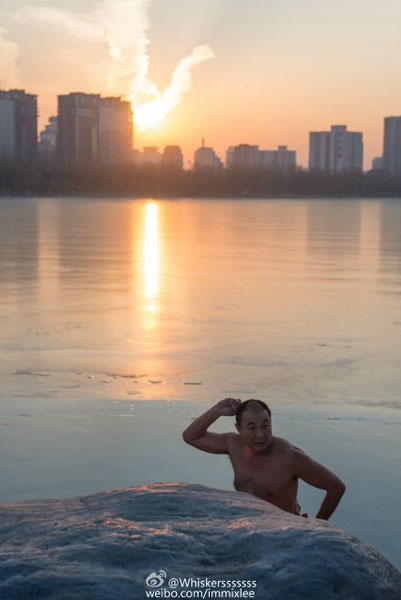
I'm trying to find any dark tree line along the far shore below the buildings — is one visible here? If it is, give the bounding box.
[0,162,401,198]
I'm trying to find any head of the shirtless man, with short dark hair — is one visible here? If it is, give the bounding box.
[235,399,273,452]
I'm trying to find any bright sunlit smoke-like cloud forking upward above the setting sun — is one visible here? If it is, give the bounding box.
[21,0,214,129]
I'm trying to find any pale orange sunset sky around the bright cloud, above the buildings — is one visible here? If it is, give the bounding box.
[0,0,401,170]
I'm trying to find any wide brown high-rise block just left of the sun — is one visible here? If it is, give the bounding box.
[57,93,133,166]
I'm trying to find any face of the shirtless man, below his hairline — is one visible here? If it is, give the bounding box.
[235,406,273,452]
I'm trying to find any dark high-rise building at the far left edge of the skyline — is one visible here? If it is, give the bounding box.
[0,90,38,162]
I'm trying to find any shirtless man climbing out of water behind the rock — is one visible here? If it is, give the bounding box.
[182,398,345,519]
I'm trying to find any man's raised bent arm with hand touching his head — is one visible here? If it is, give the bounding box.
[182,398,241,454]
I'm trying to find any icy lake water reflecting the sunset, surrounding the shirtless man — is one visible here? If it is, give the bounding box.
[0,198,401,567]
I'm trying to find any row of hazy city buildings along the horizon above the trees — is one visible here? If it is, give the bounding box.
[4,90,401,176]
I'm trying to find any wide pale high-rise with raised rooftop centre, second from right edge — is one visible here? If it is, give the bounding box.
[309,125,363,173]
